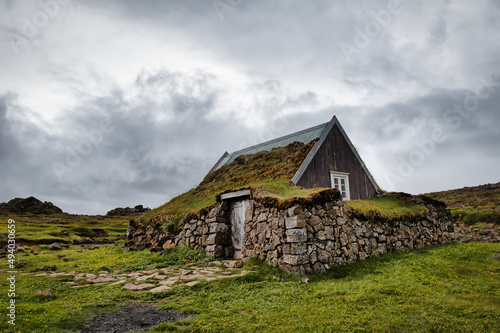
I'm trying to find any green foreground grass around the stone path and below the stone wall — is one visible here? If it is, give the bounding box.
[0,243,500,332]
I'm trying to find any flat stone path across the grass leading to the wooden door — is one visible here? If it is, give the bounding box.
[21,260,249,292]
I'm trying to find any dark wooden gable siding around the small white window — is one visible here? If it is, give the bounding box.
[297,125,376,200]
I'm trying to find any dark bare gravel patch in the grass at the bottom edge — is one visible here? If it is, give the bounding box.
[80,303,189,333]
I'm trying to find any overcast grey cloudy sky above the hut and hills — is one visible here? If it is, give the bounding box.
[0,0,500,214]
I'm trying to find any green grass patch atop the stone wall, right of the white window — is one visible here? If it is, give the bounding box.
[344,193,426,219]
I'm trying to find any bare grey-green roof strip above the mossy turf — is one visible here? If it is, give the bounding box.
[210,123,328,171]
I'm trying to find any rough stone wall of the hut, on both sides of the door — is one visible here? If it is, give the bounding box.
[129,189,454,274]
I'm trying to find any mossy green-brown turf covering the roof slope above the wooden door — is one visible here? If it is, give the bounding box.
[140,139,317,223]
